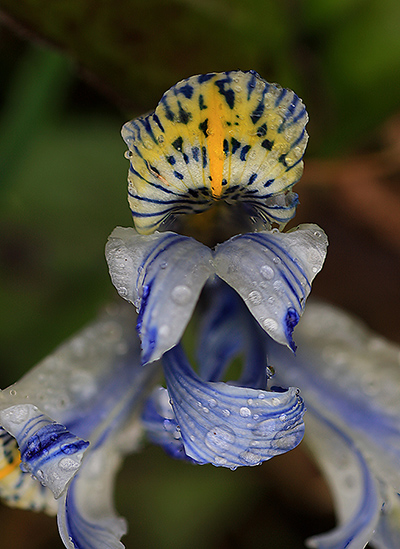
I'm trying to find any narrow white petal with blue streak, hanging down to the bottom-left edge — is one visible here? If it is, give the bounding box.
[57,439,127,549]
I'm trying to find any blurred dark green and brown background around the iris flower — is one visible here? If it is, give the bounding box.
[0,0,400,549]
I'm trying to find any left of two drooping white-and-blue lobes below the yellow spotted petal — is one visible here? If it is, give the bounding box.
[106,227,214,363]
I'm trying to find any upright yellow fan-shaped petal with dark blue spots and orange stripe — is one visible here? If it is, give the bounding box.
[122,71,308,234]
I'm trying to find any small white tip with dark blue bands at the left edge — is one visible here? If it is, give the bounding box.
[0,404,89,498]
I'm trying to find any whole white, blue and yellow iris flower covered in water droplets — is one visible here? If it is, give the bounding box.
[0,71,399,549]
